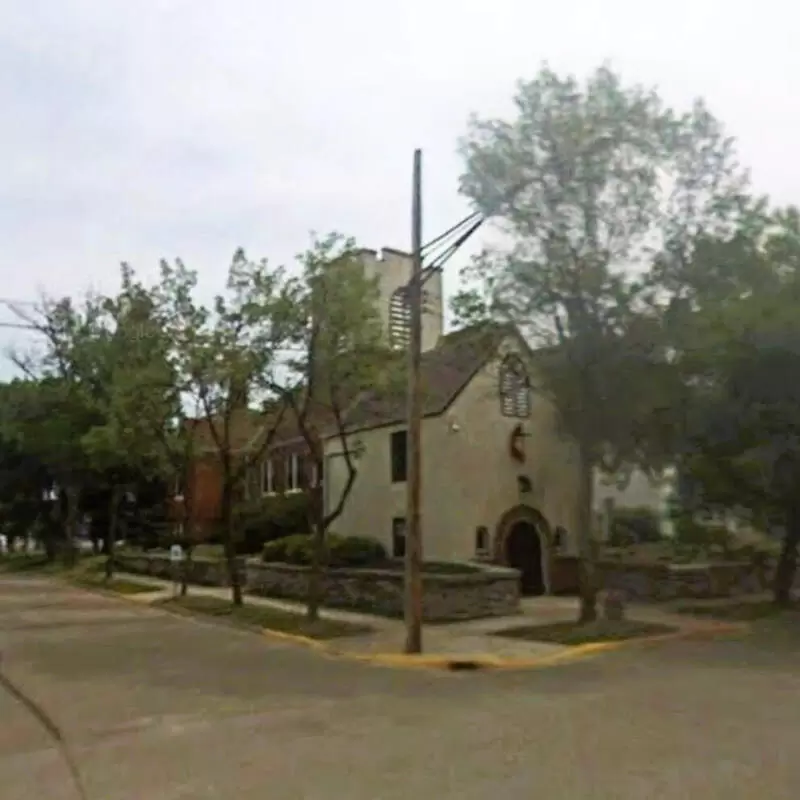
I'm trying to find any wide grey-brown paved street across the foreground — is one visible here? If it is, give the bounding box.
[0,578,800,800]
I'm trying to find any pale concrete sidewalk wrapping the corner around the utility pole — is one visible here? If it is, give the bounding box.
[109,573,740,665]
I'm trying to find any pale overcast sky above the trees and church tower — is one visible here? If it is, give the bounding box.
[0,0,800,366]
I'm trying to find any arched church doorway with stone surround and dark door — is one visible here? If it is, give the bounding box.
[495,505,550,595]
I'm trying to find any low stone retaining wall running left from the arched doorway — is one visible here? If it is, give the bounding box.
[116,553,520,622]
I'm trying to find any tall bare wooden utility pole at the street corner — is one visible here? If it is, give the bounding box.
[405,150,422,653]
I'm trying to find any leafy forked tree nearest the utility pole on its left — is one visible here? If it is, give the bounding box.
[271,234,396,621]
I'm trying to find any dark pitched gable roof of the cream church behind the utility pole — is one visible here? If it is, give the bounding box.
[336,323,516,431]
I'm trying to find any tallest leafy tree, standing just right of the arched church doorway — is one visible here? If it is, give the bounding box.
[455,67,747,621]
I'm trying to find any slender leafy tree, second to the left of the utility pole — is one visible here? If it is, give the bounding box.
[162,250,288,605]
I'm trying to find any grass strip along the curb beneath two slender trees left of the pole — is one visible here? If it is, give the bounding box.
[156,594,371,639]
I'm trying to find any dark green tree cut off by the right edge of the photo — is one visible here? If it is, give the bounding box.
[679,209,800,605]
